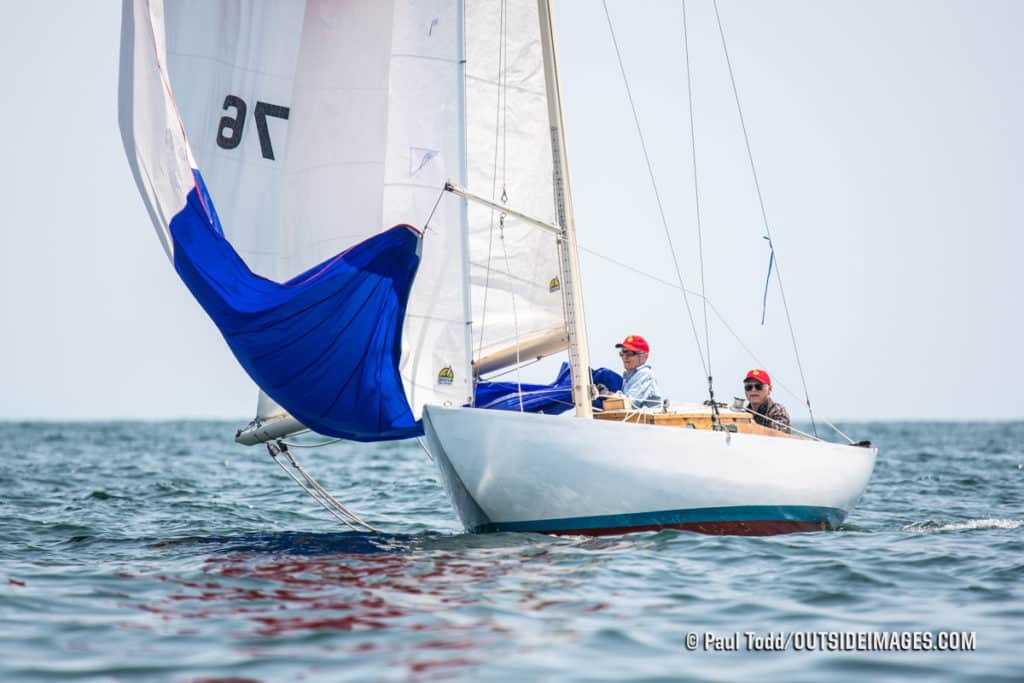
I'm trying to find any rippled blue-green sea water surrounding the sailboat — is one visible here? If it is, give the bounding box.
[0,422,1024,682]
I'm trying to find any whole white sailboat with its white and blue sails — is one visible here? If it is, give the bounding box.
[119,0,877,535]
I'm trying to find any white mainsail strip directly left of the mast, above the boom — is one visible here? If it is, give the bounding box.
[466,1,565,367]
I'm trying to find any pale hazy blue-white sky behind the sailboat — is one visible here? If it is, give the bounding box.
[0,0,1024,423]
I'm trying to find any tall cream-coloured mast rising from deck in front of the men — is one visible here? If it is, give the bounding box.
[537,0,594,418]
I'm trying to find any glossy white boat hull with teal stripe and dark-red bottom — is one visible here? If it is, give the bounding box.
[423,405,878,533]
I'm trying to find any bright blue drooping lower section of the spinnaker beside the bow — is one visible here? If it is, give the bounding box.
[170,171,423,441]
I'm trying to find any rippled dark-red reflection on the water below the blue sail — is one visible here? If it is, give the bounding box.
[138,553,516,659]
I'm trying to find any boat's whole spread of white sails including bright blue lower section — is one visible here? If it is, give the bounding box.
[120,0,564,439]
